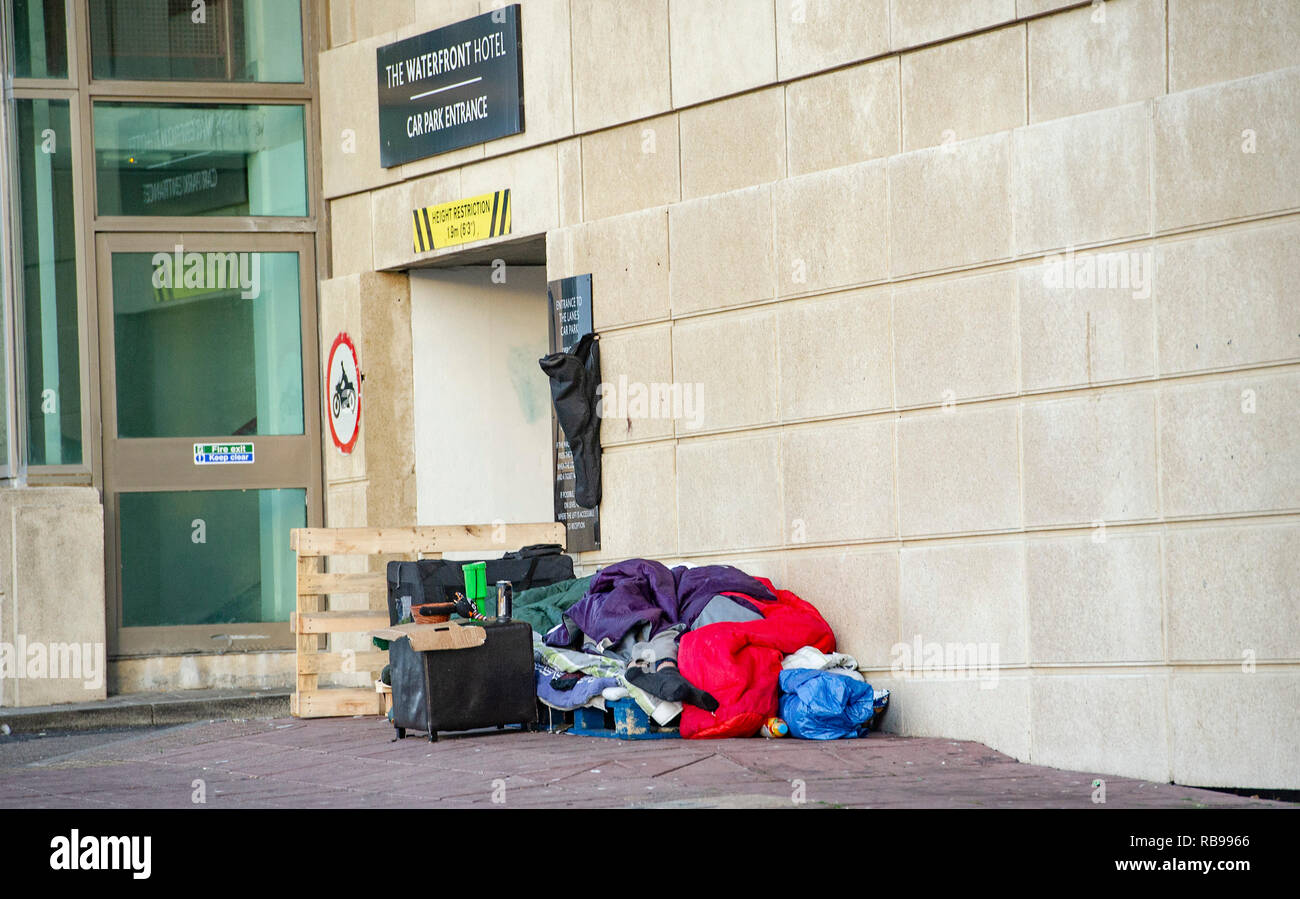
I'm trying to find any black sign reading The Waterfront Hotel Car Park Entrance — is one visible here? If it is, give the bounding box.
[376,4,524,169]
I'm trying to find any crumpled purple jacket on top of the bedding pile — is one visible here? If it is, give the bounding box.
[545,559,776,646]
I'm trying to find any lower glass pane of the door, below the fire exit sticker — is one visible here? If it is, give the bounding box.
[118,488,307,627]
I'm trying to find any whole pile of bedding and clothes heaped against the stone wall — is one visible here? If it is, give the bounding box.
[515,559,883,739]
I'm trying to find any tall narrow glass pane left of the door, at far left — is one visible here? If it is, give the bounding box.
[14,100,82,465]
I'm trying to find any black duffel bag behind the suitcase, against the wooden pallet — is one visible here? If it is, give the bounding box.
[387,543,573,625]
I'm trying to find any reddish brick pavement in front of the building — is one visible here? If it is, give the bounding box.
[0,717,1288,808]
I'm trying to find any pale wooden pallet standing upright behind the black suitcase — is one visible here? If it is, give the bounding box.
[289,522,564,718]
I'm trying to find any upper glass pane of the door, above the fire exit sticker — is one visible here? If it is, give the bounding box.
[112,248,303,437]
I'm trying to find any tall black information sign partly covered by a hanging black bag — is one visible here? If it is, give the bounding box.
[546,274,601,552]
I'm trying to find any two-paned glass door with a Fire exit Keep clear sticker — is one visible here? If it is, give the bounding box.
[96,234,321,655]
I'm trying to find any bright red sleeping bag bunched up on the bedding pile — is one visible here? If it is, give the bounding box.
[677,578,835,739]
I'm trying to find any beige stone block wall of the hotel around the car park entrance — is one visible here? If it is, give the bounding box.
[319,0,1300,789]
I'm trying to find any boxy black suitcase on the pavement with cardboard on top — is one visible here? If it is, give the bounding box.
[389,621,537,742]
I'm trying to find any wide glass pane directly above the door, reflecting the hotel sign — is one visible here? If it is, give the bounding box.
[95,103,307,216]
